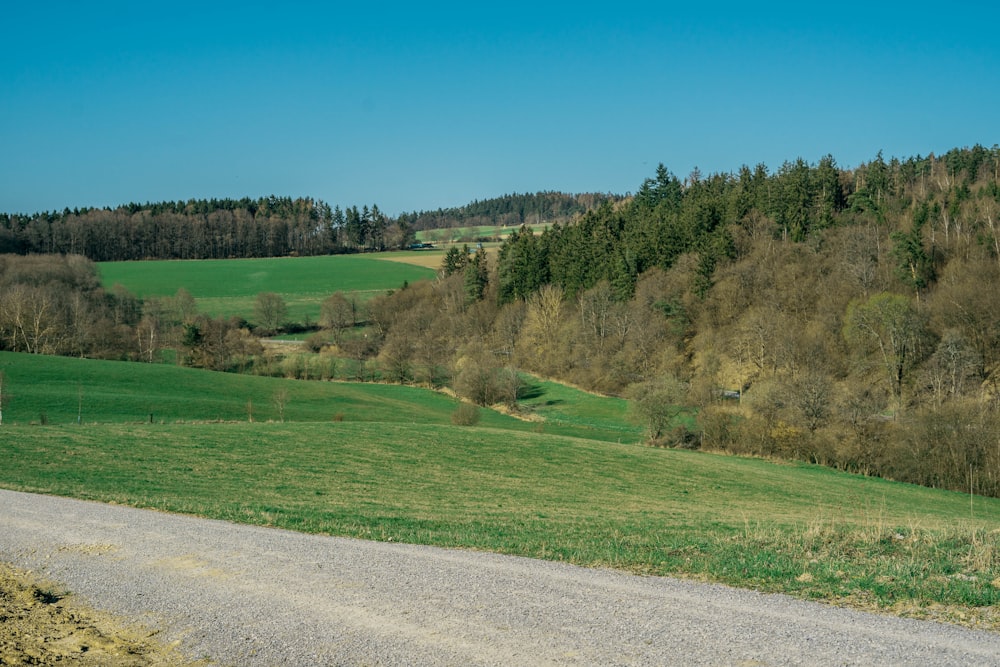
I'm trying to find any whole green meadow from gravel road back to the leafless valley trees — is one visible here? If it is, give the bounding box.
[0,353,1000,629]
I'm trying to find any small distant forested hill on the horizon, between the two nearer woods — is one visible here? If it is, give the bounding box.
[399,192,622,230]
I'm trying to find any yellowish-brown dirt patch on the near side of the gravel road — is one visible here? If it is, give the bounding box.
[0,563,197,667]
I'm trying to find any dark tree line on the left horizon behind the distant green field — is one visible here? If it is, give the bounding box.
[0,196,414,262]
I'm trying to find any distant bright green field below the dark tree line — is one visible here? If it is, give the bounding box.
[98,255,435,322]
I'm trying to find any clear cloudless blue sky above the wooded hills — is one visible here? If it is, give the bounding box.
[0,0,1000,214]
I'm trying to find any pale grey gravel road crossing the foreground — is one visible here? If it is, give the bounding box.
[0,491,1000,665]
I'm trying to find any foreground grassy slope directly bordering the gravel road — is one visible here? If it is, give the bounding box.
[0,422,1000,627]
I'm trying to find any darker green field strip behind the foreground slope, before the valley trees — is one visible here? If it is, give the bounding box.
[0,352,641,442]
